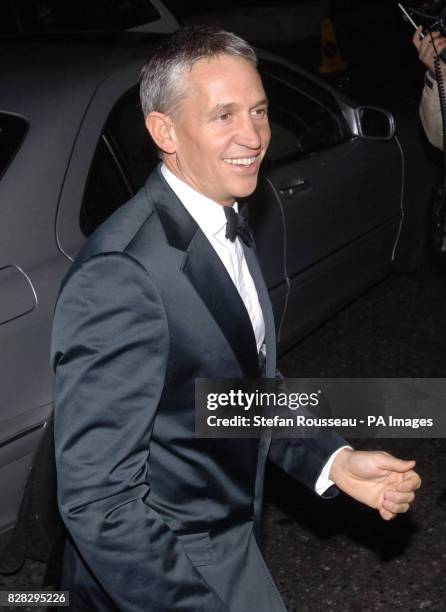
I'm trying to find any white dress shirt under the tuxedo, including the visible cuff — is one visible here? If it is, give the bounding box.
[161,164,350,495]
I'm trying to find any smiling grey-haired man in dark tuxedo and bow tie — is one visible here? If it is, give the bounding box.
[52,28,420,612]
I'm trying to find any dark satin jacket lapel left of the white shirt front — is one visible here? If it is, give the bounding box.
[147,170,259,378]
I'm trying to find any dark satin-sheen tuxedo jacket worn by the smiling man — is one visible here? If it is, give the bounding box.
[52,169,342,612]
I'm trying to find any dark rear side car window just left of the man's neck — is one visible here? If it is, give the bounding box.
[80,87,159,236]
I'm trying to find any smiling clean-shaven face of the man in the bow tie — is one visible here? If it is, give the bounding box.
[164,55,271,205]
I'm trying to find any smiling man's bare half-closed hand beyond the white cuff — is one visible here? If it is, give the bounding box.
[329,448,421,521]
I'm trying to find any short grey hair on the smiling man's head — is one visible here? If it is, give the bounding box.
[140,26,257,117]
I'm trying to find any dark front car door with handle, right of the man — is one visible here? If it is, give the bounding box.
[251,61,402,350]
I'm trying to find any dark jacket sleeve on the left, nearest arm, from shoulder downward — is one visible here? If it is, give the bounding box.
[52,253,228,612]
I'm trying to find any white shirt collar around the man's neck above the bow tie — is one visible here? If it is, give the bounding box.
[161,164,238,237]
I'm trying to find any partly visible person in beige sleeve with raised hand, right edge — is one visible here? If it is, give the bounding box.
[412,27,446,149]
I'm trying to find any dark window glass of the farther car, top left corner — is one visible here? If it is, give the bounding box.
[0,0,160,34]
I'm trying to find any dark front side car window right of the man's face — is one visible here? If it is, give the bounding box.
[262,64,348,162]
